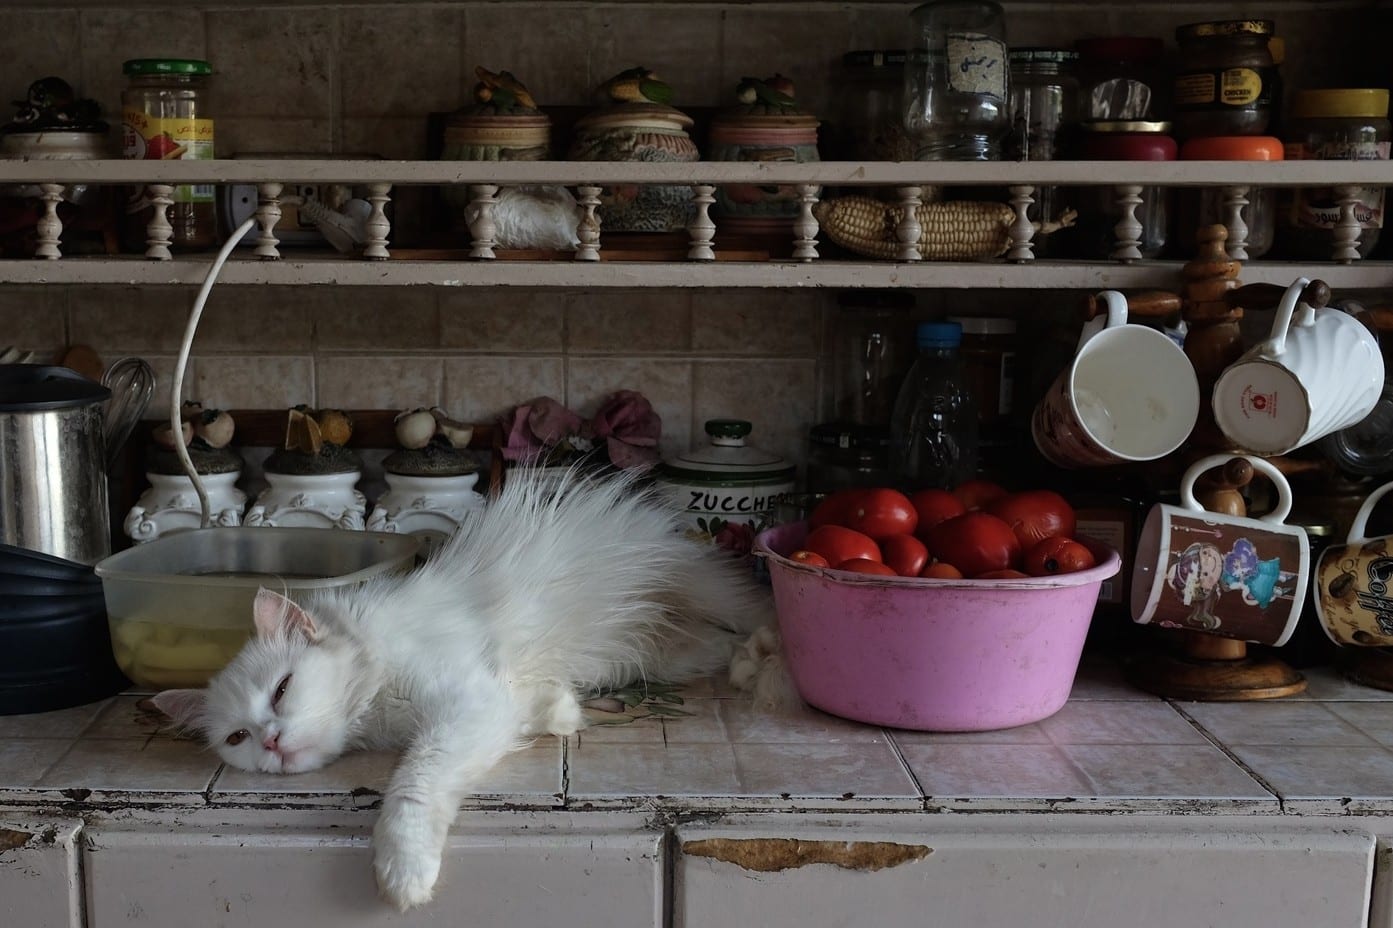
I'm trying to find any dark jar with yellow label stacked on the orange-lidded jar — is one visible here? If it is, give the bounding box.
[1173,20,1276,139]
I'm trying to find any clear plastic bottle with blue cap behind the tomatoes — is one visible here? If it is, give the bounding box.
[890,322,976,489]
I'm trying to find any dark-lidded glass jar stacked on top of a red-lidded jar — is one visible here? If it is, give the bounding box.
[1074,35,1170,121]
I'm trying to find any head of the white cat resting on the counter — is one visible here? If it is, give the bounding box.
[155,591,352,773]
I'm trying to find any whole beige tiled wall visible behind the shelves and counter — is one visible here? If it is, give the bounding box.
[0,0,1386,473]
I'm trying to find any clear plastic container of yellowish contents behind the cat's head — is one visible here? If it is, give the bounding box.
[96,527,422,687]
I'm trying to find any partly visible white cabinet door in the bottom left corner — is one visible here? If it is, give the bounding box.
[0,817,82,928]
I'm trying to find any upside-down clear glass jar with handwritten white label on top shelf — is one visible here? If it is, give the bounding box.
[904,0,1011,162]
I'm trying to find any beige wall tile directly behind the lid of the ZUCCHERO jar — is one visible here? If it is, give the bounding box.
[691,361,818,464]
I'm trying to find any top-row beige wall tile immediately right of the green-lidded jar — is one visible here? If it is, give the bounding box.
[206,7,338,118]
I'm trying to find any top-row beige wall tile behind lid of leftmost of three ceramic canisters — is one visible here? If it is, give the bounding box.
[457,3,585,107]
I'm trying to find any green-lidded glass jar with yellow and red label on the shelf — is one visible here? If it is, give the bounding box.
[121,59,217,251]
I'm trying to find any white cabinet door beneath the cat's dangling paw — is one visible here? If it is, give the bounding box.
[84,810,663,928]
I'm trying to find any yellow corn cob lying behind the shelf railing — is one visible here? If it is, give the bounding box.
[812,196,1015,261]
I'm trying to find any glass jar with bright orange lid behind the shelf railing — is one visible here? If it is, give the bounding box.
[1176,135,1282,261]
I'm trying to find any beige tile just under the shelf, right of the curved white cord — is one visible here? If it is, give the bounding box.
[195,287,314,354]
